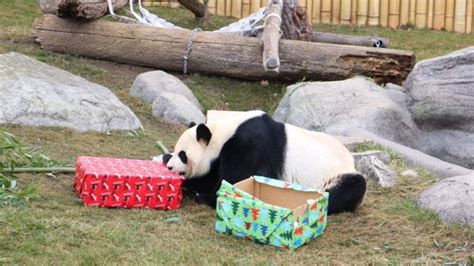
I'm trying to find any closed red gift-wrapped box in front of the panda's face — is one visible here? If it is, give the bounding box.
[74,156,184,210]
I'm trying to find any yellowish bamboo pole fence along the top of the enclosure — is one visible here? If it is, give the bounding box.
[143,0,474,33]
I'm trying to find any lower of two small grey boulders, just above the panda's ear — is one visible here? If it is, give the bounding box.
[152,93,206,126]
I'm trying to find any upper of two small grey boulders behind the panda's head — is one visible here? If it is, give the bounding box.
[130,70,201,109]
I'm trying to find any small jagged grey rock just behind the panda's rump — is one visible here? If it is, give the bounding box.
[355,156,397,187]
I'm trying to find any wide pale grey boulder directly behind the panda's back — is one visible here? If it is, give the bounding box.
[273,77,418,147]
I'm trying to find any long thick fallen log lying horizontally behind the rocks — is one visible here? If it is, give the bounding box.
[33,15,415,84]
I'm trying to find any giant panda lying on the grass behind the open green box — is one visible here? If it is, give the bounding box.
[163,111,366,214]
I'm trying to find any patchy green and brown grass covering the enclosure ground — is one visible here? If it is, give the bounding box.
[0,0,474,265]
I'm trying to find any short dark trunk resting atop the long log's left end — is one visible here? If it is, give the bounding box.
[51,0,127,20]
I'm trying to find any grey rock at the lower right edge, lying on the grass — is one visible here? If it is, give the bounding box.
[417,174,474,226]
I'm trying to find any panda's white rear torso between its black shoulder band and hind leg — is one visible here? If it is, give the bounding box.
[281,124,356,189]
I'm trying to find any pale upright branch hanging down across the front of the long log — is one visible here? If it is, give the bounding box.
[262,0,283,76]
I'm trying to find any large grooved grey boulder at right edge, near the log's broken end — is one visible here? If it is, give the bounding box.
[404,46,474,132]
